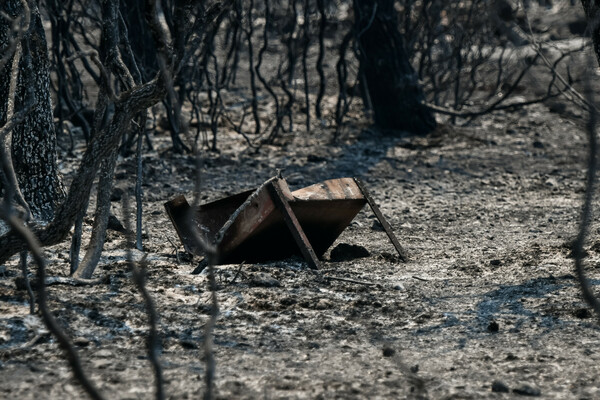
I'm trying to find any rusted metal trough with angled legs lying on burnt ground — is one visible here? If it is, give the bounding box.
[165,178,406,269]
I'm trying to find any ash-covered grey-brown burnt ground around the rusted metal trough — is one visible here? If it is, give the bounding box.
[0,3,600,399]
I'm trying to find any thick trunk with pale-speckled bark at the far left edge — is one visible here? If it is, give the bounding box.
[0,0,64,222]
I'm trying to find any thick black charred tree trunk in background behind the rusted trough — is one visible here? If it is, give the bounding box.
[354,0,436,134]
